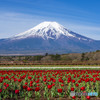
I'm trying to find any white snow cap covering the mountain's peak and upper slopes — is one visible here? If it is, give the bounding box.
[13,21,75,39]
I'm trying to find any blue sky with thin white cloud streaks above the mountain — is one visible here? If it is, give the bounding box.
[0,0,100,40]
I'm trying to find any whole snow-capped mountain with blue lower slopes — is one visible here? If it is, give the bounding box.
[0,22,100,54]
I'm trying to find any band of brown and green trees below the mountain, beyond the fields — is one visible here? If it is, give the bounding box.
[0,50,100,64]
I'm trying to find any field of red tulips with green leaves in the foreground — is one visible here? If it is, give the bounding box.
[0,68,100,100]
